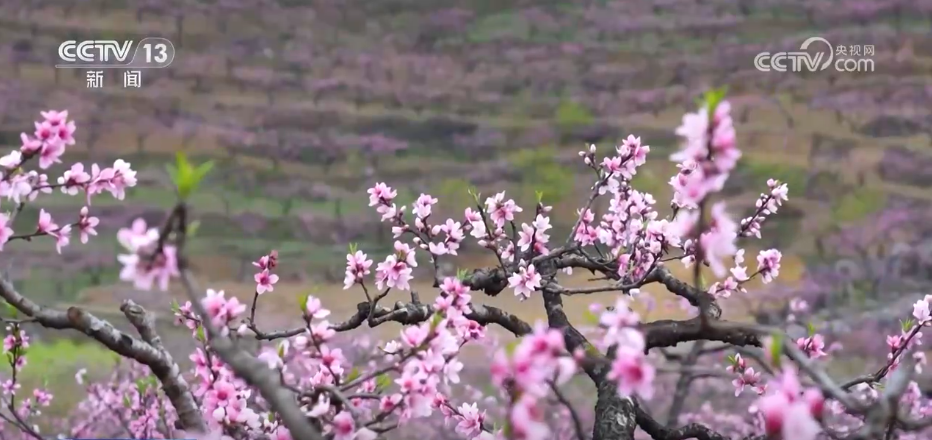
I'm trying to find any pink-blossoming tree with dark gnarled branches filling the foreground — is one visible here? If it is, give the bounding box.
[0,91,932,440]
